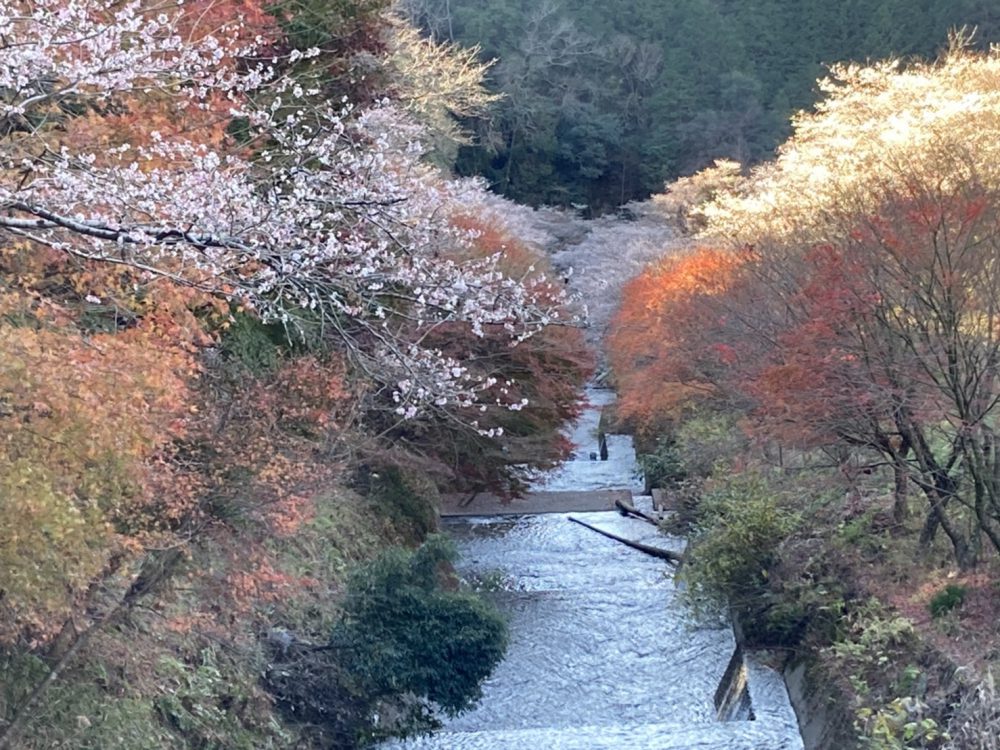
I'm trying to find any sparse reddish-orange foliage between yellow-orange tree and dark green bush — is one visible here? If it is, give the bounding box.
[168,348,355,635]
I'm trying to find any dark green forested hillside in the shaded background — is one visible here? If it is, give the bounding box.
[403,0,1000,209]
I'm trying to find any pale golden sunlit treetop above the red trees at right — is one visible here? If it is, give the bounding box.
[701,37,1000,241]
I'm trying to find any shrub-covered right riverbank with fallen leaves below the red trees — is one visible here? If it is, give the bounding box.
[632,438,998,750]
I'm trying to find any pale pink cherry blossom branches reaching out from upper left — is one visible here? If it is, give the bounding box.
[0,0,562,418]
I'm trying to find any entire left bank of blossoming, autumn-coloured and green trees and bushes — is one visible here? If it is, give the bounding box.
[0,0,588,750]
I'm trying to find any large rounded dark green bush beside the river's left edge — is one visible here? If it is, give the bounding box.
[267,536,507,748]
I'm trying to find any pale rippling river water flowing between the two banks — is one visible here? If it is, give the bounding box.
[389,391,802,750]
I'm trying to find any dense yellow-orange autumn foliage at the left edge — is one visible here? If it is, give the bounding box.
[0,284,197,640]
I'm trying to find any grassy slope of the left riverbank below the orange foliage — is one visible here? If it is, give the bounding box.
[0,478,446,750]
